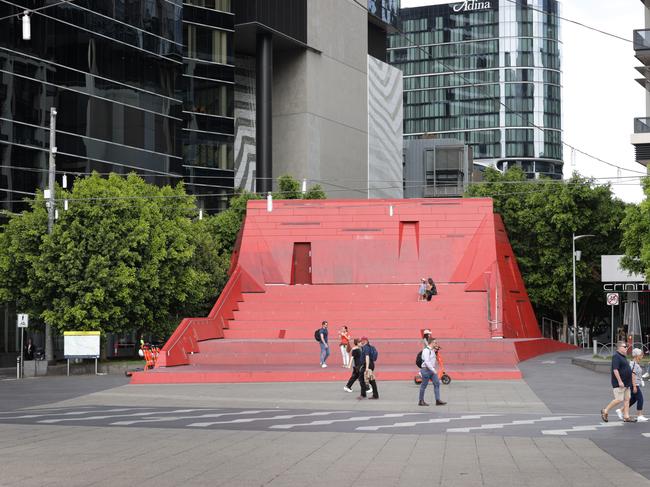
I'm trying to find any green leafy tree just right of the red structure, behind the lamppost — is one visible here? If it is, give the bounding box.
[468,169,625,337]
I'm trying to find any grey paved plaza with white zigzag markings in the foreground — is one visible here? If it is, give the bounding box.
[0,353,650,487]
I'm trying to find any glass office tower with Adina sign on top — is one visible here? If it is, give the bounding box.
[389,0,563,179]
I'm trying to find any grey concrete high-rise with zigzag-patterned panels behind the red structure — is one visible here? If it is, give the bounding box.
[234,0,402,198]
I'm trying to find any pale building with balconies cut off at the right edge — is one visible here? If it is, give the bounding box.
[632,0,650,171]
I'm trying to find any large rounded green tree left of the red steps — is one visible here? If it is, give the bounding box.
[0,175,226,335]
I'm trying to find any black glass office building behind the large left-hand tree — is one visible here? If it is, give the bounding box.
[0,0,234,217]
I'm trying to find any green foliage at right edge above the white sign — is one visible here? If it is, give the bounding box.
[622,178,650,279]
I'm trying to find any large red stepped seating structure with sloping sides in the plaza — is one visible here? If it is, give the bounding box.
[132,198,572,383]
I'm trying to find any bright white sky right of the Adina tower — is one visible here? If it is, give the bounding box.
[401,0,646,203]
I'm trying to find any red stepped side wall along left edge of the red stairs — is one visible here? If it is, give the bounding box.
[156,266,242,367]
